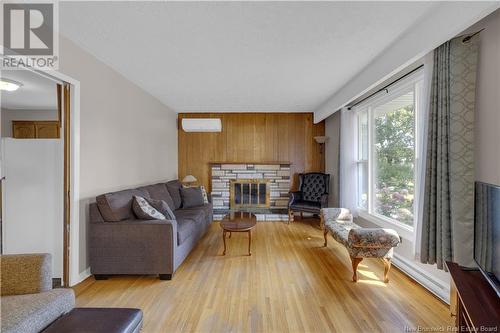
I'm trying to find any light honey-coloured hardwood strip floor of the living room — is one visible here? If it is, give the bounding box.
[75,220,452,332]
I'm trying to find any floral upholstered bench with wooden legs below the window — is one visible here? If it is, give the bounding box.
[320,208,401,283]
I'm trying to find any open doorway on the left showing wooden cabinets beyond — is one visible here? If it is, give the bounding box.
[0,70,72,286]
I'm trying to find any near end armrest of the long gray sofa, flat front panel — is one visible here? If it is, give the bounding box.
[89,220,177,274]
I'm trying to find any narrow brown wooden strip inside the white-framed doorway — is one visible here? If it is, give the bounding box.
[63,83,71,287]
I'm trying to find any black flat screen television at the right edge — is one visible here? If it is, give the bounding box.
[474,182,500,297]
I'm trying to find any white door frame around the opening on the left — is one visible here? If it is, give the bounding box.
[0,54,81,287]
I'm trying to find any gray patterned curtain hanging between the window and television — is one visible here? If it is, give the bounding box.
[420,36,479,269]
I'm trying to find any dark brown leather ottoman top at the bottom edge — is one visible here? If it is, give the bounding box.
[43,308,142,333]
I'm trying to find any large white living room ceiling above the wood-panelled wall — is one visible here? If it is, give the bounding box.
[59,2,437,112]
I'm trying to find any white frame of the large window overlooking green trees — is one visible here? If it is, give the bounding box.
[354,69,424,239]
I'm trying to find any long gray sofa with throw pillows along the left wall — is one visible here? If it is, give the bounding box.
[89,180,213,280]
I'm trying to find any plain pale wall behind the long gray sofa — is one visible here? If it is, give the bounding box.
[59,37,177,279]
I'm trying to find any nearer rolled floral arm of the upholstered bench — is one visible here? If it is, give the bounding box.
[347,228,401,248]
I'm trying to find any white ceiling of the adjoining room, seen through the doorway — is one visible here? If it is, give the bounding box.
[0,70,57,110]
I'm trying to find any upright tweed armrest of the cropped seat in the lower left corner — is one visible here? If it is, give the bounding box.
[0,253,52,296]
